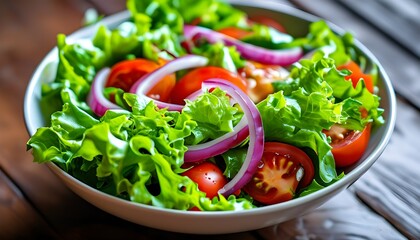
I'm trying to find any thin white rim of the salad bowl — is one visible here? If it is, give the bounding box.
[23,0,397,227]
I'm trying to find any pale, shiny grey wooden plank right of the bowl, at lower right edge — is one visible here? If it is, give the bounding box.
[352,98,420,239]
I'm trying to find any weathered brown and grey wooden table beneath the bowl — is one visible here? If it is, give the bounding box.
[0,0,420,239]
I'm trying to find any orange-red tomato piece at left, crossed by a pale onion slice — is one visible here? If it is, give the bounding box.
[106,58,175,101]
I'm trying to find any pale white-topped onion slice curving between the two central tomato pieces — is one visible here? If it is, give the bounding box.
[130,55,208,112]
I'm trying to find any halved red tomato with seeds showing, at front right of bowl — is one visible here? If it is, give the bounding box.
[244,142,315,204]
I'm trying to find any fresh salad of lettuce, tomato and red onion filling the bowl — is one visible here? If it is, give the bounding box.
[27,0,384,211]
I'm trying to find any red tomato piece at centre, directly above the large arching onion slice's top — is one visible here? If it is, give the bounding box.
[171,66,246,104]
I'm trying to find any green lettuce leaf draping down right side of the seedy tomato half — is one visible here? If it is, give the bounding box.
[257,90,340,184]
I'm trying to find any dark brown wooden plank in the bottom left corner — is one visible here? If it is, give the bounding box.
[0,168,57,239]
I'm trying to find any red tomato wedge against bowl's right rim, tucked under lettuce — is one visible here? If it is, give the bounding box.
[325,124,371,167]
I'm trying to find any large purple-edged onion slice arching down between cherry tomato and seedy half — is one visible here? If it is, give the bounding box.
[198,78,264,196]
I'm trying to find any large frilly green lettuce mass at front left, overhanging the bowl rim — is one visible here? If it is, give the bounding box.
[28,89,253,210]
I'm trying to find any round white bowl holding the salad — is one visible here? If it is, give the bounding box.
[24,0,396,234]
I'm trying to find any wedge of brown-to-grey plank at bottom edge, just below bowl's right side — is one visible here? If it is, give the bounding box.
[259,190,405,240]
